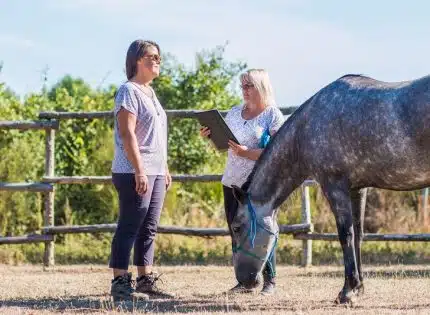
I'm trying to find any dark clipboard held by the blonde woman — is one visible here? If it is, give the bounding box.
[195,109,240,151]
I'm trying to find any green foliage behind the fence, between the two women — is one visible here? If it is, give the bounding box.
[154,46,246,222]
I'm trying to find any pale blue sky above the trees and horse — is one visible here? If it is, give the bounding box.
[0,0,430,106]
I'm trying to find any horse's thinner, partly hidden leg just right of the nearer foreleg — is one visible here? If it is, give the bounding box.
[351,188,367,294]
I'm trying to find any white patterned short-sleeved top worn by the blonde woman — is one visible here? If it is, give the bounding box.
[221,105,284,187]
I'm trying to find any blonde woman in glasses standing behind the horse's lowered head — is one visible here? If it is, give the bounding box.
[200,69,284,295]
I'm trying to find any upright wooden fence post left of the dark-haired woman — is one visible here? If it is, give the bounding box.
[43,129,55,267]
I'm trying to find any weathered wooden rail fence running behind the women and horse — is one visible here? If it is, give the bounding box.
[0,107,430,267]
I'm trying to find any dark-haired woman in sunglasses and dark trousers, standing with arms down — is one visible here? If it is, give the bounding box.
[109,40,171,300]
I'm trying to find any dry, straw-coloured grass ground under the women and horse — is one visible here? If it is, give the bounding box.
[0,265,430,315]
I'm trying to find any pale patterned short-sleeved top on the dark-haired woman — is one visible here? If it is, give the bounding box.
[112,81,167,175]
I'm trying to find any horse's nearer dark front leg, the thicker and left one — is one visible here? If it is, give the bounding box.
[322,180,361,304]
